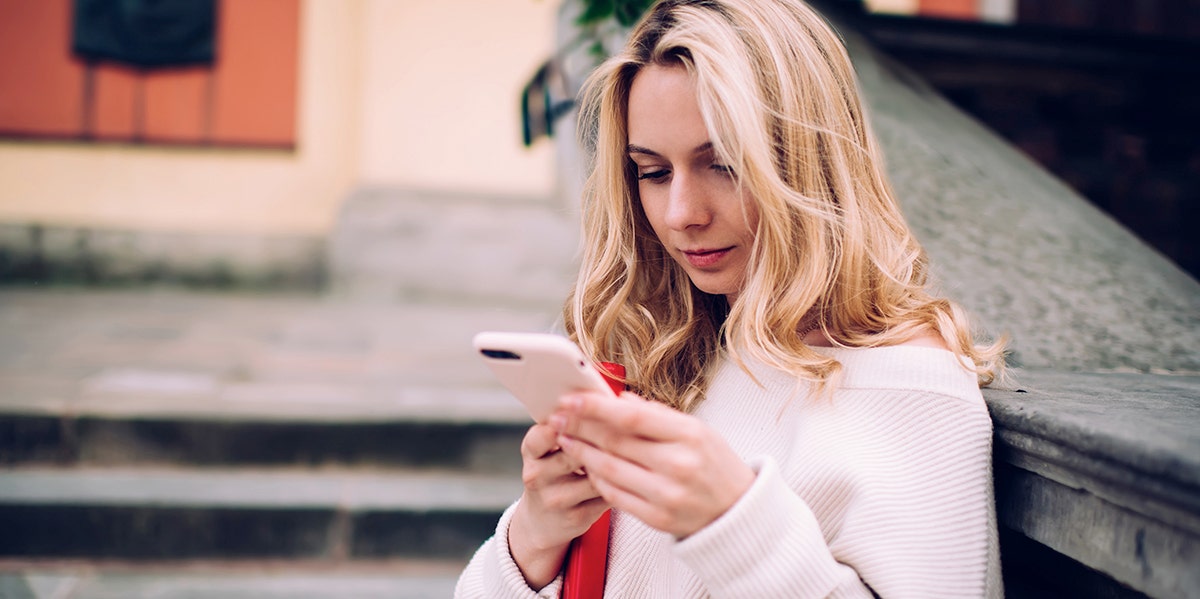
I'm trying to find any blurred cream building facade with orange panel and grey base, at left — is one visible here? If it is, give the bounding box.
[0,0,557,286]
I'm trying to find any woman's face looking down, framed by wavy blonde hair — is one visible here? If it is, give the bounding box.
[626,65,758,304]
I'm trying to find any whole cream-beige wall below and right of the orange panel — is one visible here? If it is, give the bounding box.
[0,0,557,234]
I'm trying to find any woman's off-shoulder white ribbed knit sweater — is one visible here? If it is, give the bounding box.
[456,346,1003,599]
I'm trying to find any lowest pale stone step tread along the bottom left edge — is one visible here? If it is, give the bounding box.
[0,559,466,599]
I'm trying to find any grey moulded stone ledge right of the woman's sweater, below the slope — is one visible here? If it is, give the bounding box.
[984,371,1200,597]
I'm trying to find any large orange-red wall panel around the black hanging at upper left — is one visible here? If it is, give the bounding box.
[0,0,300,146]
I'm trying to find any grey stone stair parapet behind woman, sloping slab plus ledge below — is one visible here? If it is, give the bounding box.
[827,3,1200,597]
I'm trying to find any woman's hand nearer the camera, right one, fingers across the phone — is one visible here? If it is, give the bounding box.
[551,393,755,538]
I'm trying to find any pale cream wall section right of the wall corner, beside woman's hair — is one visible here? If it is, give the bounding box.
[362,0,558,197]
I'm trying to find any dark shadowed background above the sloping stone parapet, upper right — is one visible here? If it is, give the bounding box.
[865,0,1200,277]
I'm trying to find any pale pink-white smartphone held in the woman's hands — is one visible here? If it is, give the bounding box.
[474,331,612,423]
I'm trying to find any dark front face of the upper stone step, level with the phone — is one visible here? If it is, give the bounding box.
[0,408,532,473]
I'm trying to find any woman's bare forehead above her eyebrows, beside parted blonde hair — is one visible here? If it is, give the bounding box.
[626,65,709,154]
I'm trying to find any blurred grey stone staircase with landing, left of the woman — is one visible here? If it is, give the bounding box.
[0,289,566,599]
